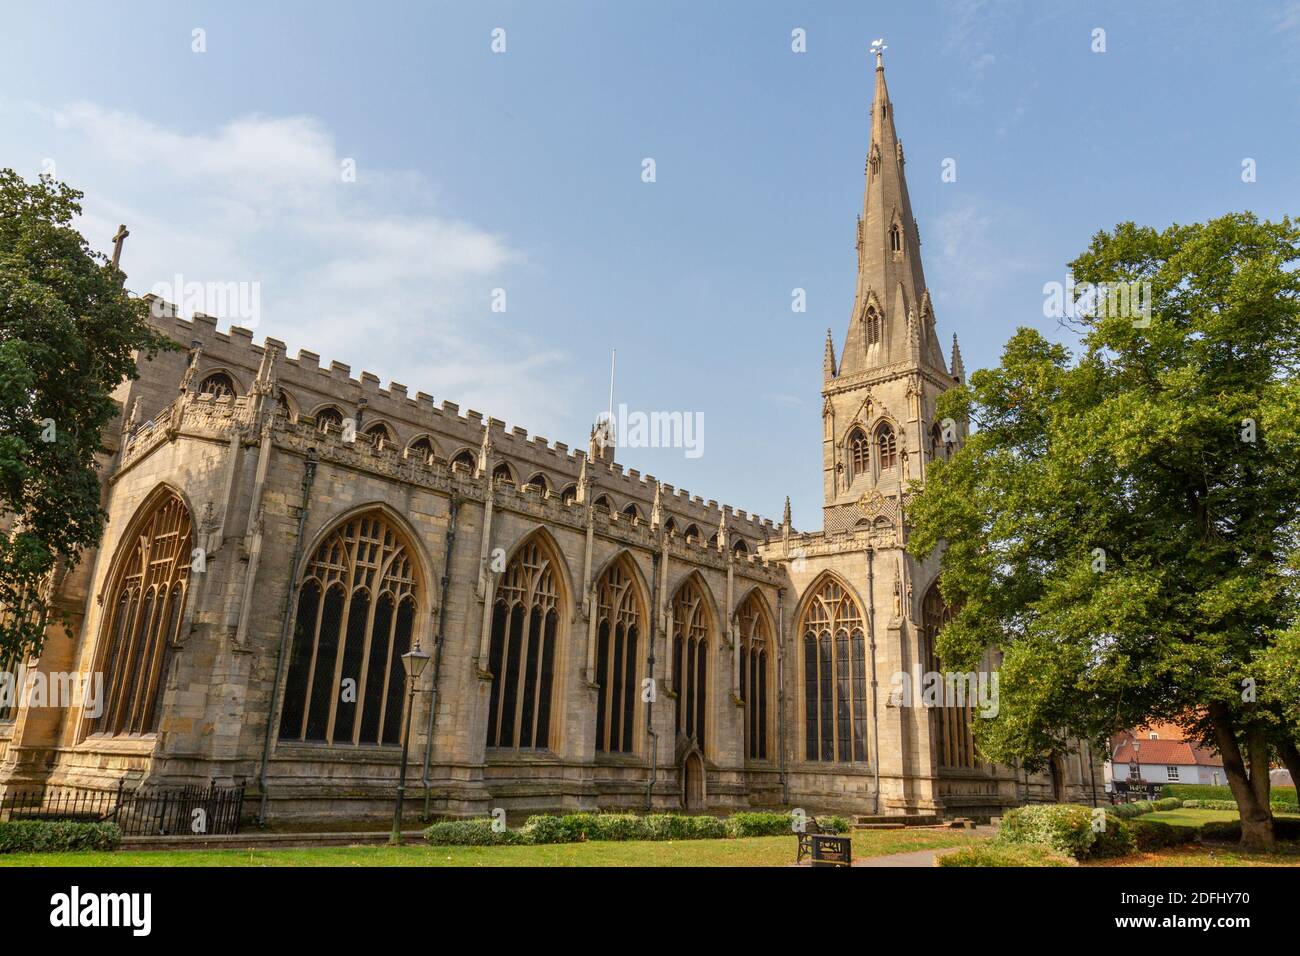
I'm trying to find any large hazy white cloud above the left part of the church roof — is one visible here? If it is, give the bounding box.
[15,103,572,433]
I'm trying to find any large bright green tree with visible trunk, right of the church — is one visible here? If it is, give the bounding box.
[910,213,1300,847]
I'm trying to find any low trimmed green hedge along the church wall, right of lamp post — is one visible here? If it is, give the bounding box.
[424,813,849,847]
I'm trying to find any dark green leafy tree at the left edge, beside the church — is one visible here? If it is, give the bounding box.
[0,169,168,661]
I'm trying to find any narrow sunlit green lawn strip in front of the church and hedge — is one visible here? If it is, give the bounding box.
[0,830,988,866]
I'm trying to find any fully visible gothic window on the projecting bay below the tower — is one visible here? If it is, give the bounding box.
[798,576,867,763]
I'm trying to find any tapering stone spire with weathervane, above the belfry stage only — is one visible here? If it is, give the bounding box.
[839,42,948,377]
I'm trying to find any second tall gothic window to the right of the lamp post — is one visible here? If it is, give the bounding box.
[595,562,642,753]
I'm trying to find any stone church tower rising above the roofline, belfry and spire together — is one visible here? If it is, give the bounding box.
[822,49,965,535]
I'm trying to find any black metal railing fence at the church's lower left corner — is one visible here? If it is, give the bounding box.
[0,782,244,836]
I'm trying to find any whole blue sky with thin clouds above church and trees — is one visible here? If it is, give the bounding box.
[0,0,1300,528]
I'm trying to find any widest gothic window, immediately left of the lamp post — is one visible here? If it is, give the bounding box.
[280,511,420,745]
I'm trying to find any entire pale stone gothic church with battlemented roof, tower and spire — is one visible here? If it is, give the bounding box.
[0,56,1101,821]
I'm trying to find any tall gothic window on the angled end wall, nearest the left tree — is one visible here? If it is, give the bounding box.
[88,492,194,735]
